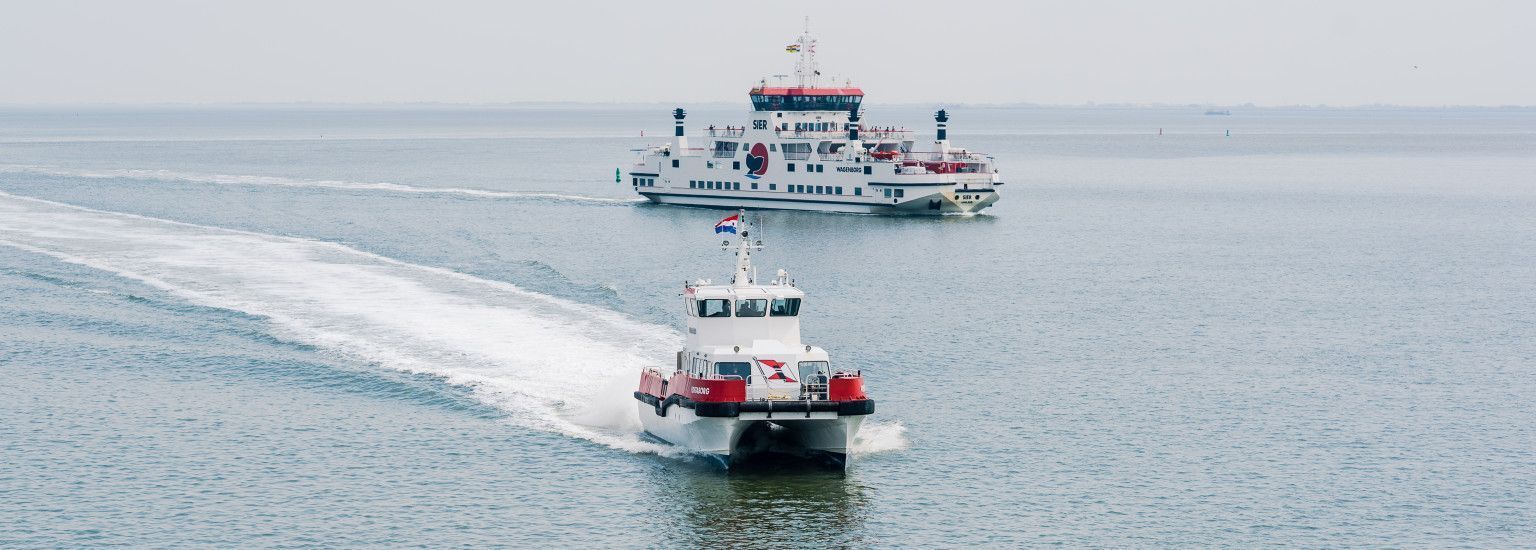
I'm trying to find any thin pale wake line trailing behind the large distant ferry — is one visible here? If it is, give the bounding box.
[0,164,645,204]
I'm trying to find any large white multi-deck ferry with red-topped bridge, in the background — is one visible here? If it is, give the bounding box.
[630,25,1003,214]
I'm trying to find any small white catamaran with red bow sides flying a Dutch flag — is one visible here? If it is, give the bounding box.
[634,214,874,467]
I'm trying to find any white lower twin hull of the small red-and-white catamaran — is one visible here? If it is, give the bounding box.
[639,403,863,464]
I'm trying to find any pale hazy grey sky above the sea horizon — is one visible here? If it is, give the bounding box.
[0,0,1536,106]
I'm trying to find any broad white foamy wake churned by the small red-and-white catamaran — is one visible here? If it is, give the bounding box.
[0,192,903,455]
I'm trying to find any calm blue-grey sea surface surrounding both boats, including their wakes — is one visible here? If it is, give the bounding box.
[0,103,1536,547]
